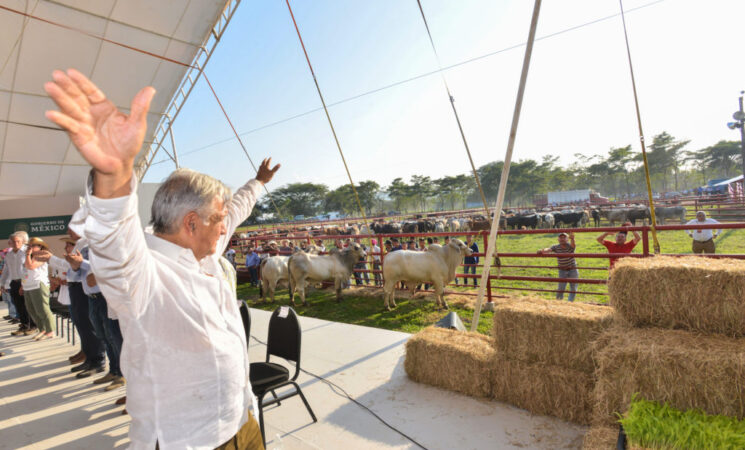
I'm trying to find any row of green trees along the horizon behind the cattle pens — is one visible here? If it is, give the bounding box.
[252,132,742,218]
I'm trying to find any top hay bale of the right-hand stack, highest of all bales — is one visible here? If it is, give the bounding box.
[608,256,745,337]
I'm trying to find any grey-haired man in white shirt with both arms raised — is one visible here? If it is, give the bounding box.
[45,69,279,450]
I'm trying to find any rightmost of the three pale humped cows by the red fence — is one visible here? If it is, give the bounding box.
[383,239,473,311]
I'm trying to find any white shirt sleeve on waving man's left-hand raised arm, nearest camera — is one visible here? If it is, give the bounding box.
[77,176,155,317]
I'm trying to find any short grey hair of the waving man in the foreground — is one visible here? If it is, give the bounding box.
[150,169,233,234]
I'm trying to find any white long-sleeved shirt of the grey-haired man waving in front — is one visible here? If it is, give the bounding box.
[70,177,261,450]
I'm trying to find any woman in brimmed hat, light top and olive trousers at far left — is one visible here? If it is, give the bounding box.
[21,237,54,341]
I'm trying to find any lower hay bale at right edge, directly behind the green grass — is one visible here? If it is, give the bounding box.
[593,327,745,423]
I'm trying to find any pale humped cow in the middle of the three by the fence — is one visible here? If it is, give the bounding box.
[287,243,364,306]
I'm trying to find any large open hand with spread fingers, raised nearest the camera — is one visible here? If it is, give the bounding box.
[44,69,155,197]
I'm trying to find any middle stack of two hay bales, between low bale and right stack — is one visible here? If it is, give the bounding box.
[492,297,614,424]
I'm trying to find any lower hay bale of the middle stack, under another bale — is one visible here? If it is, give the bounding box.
[492,357,593,424]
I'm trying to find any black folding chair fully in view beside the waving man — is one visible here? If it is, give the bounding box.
[251,306,318,446]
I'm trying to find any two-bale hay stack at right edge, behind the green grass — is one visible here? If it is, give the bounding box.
[593,257,745,425]
